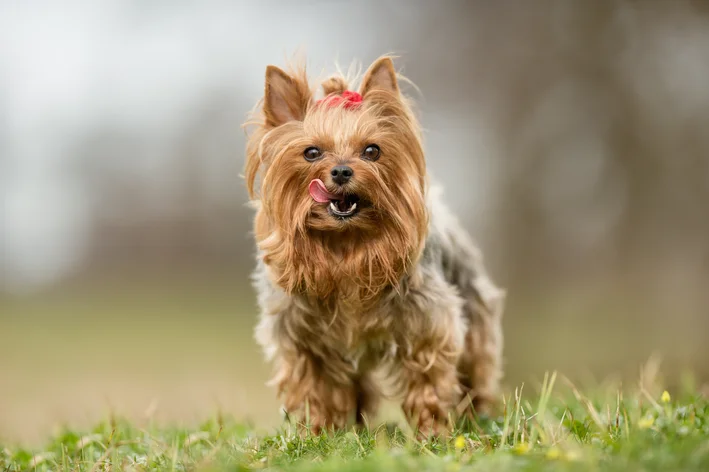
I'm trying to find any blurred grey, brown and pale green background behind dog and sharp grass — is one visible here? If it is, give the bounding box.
[0,0,709,441]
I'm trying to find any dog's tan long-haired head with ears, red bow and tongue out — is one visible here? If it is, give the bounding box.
[246,58,427,291]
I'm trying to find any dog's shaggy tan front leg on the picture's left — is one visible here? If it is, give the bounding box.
[276,349,357,434]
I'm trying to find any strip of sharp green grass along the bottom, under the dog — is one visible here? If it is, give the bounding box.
[0,374,709,472]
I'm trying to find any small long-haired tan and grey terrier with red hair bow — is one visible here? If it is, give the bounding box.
[246,57,504,434]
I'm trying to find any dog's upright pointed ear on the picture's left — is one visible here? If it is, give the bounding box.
[263,66,310,127]
